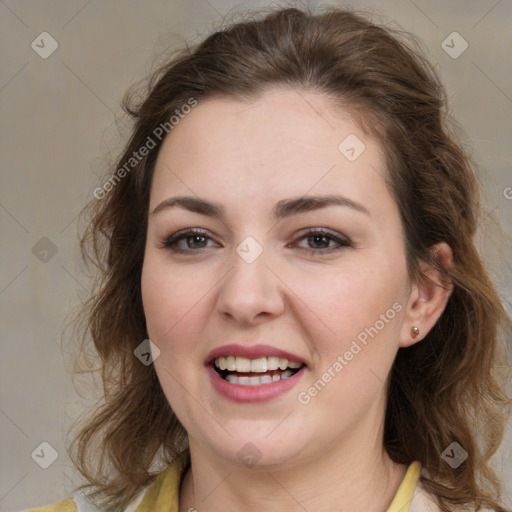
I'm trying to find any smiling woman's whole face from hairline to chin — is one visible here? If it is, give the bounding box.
[142,89,411,467]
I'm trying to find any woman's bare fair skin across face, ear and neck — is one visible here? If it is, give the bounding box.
[142,88,451,512]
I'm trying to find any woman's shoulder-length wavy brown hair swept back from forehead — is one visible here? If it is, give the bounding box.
[70,7,511,512]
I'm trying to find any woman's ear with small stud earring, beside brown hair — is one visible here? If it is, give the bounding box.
[399,242,453,347]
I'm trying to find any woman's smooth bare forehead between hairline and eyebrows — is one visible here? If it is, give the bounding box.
[151,88,385,216]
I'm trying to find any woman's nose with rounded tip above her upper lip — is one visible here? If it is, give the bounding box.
[217,243,284,324]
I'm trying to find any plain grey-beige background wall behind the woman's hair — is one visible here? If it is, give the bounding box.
[0,0,512,511]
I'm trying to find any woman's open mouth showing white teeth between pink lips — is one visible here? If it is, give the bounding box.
[213,356,305,386]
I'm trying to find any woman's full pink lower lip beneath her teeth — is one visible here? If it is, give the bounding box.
[206,366,306,403]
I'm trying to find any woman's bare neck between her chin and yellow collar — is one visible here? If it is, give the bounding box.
[179,418,407,512]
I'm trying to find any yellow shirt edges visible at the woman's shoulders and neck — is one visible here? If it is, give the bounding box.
[28,457,421,512]
